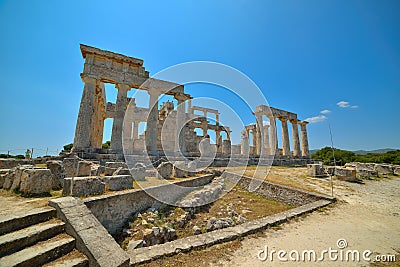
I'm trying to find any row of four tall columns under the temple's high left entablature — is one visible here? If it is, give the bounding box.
[74,76,191,153]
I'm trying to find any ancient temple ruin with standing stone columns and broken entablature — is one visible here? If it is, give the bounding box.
[73,44,309,163]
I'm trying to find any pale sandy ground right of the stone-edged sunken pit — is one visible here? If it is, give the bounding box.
[213,167,400,266]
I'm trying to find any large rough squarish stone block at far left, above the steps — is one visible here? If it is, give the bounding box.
[20,169,53,194]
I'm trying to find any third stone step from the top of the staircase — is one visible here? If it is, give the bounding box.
[0,234,75,267]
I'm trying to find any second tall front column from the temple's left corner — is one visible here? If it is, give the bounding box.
[111,84,132,151]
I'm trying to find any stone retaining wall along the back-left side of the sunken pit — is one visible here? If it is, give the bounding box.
[84,174,214,234]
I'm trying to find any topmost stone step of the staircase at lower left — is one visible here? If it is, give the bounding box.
[0,208,56,235]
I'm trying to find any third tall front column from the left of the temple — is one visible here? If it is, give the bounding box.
[146,89,160,154]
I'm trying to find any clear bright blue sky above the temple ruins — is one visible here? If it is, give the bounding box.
[0,0,400,156]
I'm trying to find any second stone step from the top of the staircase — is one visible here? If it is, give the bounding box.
[0,219,65,257]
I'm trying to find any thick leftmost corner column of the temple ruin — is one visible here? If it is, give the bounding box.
[74,76,97,150]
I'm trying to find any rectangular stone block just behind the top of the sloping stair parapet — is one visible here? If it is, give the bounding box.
[63,177,106,197]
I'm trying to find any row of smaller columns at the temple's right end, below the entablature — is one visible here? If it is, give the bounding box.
[255,114,309,157]
